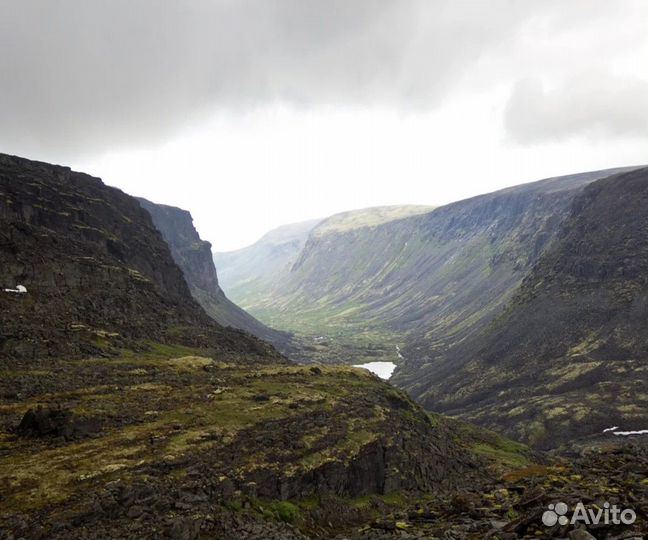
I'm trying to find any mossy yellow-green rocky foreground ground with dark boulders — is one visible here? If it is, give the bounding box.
[0,345,648,540]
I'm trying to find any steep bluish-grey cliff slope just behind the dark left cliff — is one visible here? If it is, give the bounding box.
[137,198,289,346]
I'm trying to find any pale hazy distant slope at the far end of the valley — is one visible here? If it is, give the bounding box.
[214,215,321,307]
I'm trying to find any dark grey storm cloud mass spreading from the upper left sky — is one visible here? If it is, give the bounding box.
[0,0,644,158]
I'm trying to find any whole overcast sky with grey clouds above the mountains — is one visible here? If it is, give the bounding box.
[0,0,648,251]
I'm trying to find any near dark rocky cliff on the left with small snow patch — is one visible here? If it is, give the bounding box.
[0,155,278,357]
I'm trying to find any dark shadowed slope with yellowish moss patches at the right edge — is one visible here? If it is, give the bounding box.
[395,168,648,447]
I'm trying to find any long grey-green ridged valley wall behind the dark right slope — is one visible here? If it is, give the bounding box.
[242,170,632,362]
